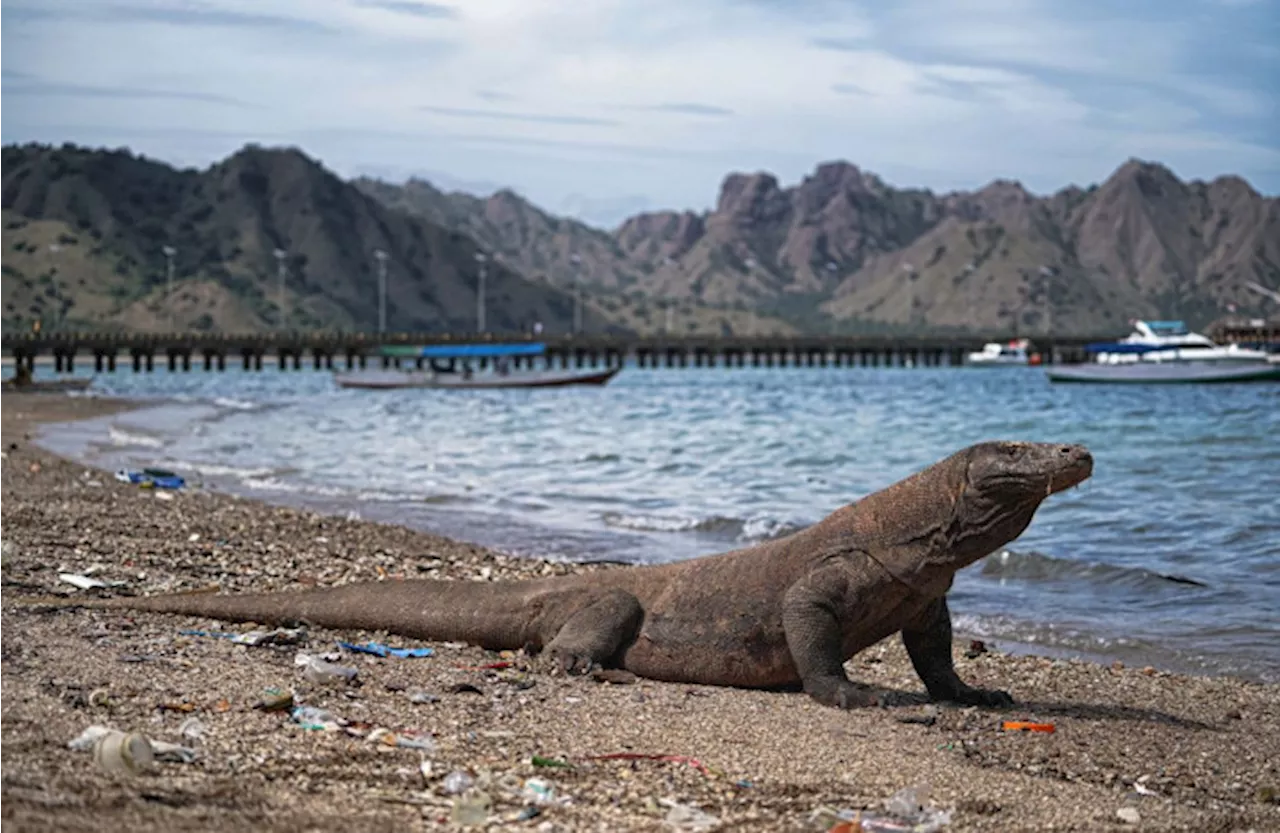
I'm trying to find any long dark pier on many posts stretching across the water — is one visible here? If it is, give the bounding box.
[0,331,1115,374]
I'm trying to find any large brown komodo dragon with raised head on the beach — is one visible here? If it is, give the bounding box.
[24,441,1093,709]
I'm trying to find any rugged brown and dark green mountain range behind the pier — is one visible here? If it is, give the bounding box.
[0,145,1280,334]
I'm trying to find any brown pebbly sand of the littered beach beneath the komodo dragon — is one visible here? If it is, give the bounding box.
[0,395,1280,833]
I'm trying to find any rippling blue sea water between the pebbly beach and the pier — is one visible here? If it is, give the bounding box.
[30,369,1280,681]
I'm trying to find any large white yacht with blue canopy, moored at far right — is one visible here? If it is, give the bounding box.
[1044,321,1280,384]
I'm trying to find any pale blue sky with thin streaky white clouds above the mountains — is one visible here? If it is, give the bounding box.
[0,0,1280,224]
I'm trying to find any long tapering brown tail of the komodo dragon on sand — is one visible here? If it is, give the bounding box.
[20,580,540,650]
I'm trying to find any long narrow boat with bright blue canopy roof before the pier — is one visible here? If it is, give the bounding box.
[333,342,622,390]
